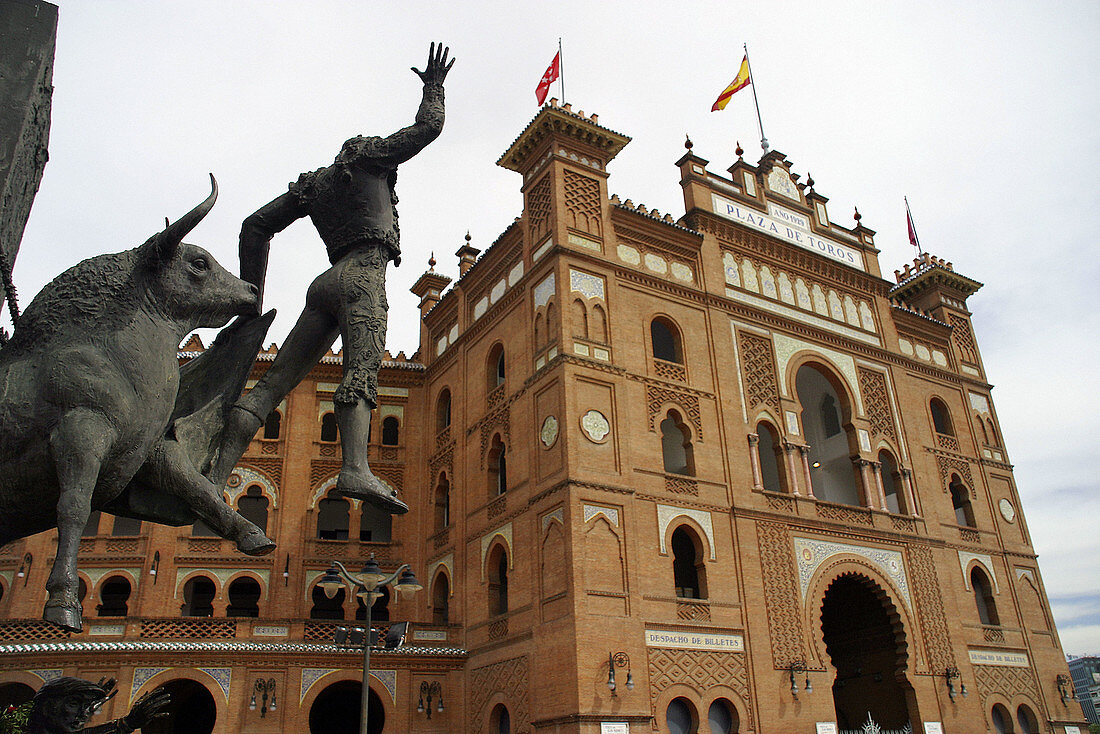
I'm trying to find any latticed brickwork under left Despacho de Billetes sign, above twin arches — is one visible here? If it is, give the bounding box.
[649,647,756,730]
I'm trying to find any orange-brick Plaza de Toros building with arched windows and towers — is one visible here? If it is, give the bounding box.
[0,101,1085,734]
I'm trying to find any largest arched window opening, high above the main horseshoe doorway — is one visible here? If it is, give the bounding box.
[794,364,860,505]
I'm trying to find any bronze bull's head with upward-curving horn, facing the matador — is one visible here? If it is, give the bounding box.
[140,174,260,332]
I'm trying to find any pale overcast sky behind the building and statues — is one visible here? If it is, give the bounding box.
[15,0,1100,654]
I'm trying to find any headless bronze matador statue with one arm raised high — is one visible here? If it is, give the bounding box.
[210,38,454,514]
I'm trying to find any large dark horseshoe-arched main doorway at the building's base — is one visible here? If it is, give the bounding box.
[822,573,916,728]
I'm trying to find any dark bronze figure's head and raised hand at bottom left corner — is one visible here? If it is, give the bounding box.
[15,677,172,734]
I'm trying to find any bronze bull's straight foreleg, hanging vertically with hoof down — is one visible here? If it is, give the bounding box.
[42,409,117,632]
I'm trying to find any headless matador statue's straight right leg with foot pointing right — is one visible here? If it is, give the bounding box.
[332,248,409,515]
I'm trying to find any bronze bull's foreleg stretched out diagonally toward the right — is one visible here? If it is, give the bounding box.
[143,440,275,556]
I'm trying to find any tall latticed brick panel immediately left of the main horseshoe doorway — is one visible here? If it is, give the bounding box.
[757,523,805,668]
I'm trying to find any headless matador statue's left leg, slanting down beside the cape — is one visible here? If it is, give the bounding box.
[209,269,340,486]
